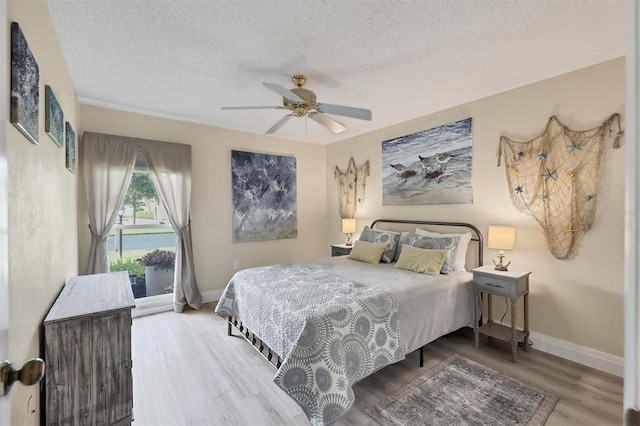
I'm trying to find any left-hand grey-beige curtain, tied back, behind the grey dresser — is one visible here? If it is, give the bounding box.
[83,132,138,274]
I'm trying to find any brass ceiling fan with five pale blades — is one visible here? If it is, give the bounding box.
[222,74,371,135]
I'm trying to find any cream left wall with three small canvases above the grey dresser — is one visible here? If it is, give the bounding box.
[7,0,78,425]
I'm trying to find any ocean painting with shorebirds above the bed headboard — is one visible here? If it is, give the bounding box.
[382,118,473,205]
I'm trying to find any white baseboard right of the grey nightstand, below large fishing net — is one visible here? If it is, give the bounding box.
[529,332,624,377]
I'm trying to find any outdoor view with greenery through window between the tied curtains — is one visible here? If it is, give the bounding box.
[107,162,176,298]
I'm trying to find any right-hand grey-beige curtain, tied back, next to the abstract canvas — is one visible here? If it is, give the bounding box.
[139,141,202,312]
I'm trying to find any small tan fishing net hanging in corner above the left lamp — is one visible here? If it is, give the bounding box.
[333,157,369,219]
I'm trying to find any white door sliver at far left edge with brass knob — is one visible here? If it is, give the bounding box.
[0,0,11,426]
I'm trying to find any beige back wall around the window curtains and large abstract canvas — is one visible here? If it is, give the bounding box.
[79,105,329,292]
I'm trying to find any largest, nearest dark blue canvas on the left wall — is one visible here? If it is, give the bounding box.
[10,22,40,145]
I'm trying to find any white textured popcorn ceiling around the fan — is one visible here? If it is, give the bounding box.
[49,0,625,144]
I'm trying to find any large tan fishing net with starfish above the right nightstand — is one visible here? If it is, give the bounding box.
[498,114,624,259]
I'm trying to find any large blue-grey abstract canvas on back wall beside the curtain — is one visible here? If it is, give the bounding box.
[231,151,298,243]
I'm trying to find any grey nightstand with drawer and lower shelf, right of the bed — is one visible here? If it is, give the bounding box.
[471,265,531,362]
